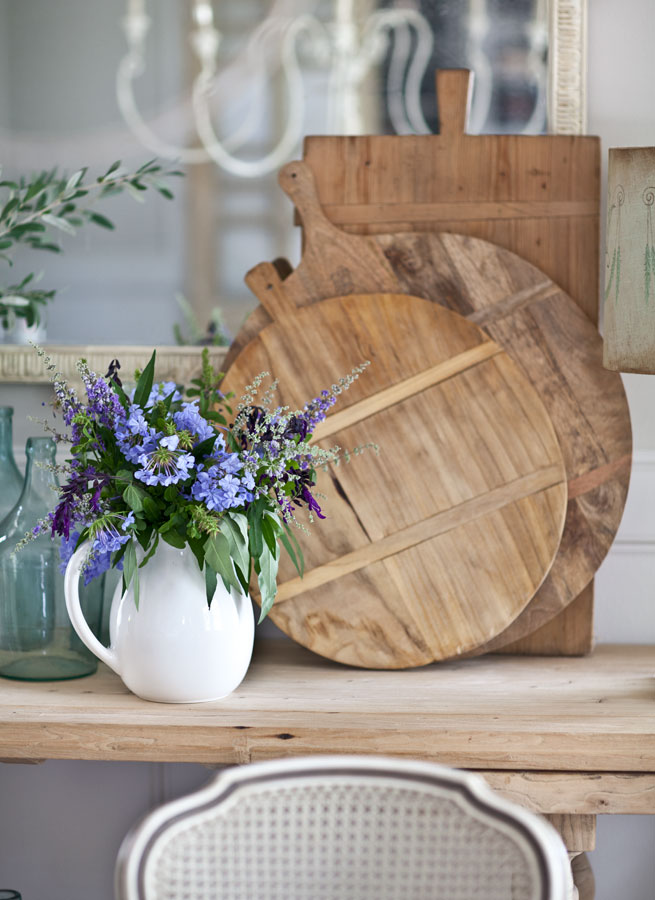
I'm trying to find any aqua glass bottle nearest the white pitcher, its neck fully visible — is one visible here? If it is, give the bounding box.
[0,437,102,681]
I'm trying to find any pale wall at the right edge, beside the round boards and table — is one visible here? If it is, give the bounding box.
[576,0,655,900]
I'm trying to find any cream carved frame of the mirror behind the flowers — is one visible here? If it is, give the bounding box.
[0,0,587,384]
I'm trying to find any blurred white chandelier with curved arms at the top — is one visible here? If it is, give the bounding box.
[116,0,433,178]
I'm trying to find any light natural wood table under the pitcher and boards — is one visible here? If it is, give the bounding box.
[0,639,655,896]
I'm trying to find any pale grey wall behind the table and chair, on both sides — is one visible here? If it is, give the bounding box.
[0,0,655,900]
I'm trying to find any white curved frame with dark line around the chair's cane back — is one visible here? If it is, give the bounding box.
[115,756,573,900]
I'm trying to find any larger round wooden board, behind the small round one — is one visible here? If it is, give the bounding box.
[226,163,632,649]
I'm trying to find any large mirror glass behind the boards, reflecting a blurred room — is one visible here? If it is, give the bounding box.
[0,0,585,381]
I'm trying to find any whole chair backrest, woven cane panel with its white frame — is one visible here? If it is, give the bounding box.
[116,756,572,900]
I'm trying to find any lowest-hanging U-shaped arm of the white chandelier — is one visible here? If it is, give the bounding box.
[192,16,313,178]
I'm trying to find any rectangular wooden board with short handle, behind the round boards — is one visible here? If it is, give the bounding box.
[304,70,601,653]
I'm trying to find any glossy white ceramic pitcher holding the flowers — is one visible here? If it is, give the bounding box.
[65,541,255,703]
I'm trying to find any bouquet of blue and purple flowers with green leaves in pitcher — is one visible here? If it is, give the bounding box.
[34,350,368,621]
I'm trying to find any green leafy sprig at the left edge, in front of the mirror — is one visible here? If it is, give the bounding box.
[0,160,183,328]
